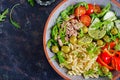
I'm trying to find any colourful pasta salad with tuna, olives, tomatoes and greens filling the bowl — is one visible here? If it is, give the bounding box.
[47,2,120,79]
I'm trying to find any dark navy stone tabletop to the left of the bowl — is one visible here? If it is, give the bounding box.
[0,0,63,80]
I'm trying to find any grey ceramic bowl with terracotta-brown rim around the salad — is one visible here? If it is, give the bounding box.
[43,0,120,80]
